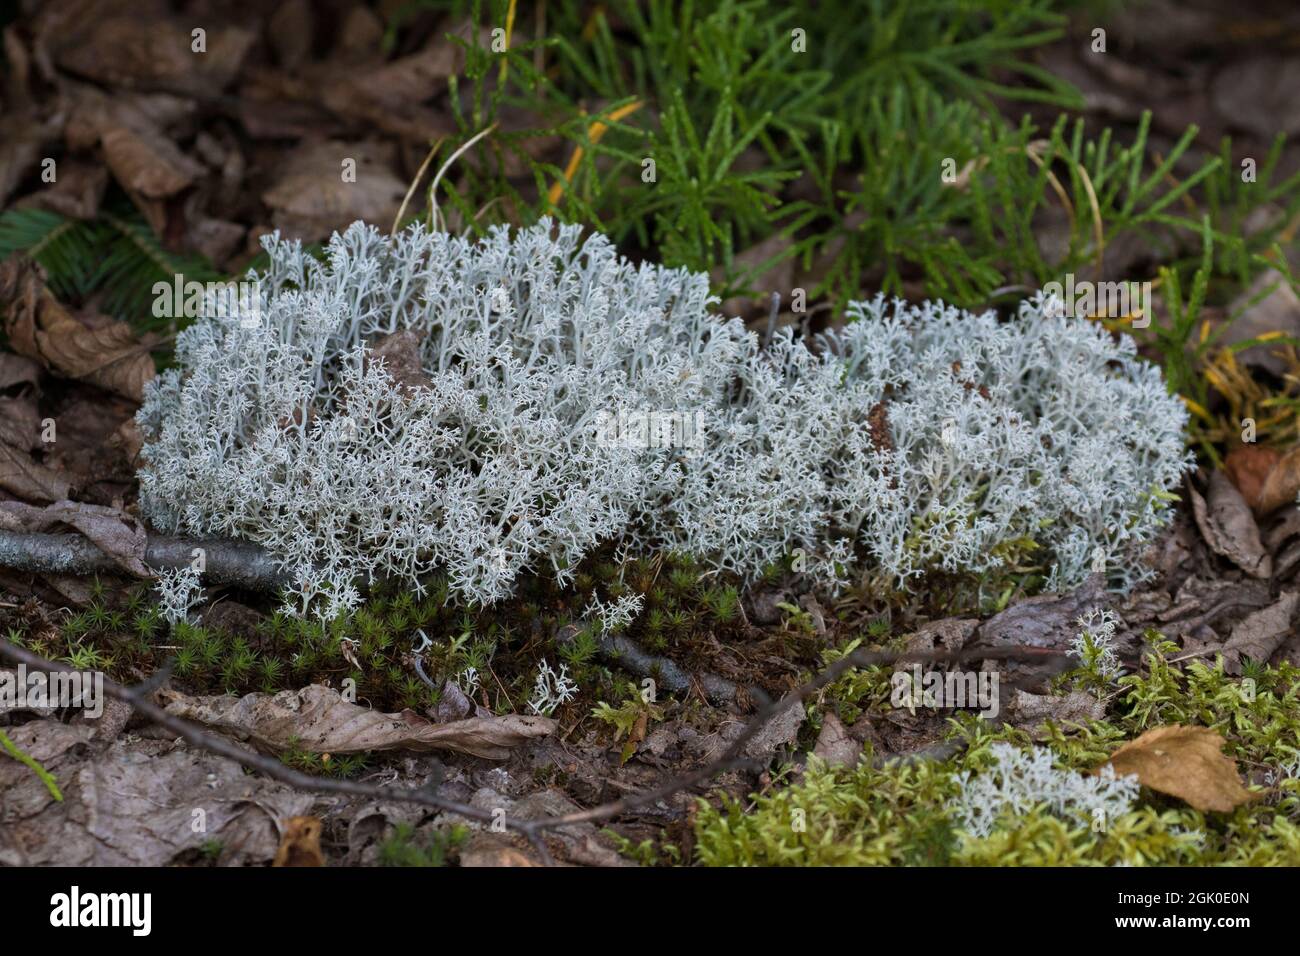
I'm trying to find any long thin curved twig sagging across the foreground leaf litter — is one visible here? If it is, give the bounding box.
[0,640,1067,865]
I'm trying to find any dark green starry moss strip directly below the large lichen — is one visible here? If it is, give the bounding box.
[0,549,745,714]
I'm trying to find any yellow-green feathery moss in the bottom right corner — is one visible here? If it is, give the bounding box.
[694,640,1300,866]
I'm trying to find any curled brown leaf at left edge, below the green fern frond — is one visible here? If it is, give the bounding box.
[0,256,155,402]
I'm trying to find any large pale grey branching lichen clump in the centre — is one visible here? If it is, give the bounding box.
[139,221,1187,615]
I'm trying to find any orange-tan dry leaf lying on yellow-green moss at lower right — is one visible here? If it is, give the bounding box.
[1099,723,1255,813]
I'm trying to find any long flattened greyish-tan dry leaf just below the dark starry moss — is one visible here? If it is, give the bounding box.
[160,684,553,760]
